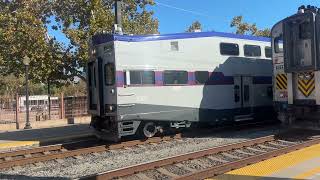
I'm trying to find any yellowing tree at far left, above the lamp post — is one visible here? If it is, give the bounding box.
[0,0,69,82]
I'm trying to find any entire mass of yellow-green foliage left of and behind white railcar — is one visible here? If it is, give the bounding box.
[0,0,158,90]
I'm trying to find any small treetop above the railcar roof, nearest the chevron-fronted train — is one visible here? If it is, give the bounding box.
[230,16,271,37]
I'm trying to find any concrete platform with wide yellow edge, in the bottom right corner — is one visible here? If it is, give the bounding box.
[213,144,320,180]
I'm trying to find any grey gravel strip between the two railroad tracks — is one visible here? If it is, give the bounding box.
[0,127,279,179]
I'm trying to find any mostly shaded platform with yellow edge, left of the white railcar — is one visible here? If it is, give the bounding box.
[0,124,94,151]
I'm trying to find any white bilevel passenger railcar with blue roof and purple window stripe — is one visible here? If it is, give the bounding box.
[87,32,274,140]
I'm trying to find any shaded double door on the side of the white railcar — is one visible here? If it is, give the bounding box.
[234,76,253,121]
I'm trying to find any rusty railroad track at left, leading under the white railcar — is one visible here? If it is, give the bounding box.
[0,134,181,169]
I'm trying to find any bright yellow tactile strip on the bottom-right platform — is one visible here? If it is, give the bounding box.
[210,144,320,179]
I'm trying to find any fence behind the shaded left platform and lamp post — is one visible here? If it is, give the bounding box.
[0,95,88,128]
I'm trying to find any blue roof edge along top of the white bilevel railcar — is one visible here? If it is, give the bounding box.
[92,32,271,44]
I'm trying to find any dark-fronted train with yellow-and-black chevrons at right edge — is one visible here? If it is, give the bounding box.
[271,5,320,128]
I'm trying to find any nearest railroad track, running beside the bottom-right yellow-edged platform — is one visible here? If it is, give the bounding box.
[80,131,320,180]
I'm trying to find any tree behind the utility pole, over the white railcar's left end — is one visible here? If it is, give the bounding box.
[53,0,158,80]
